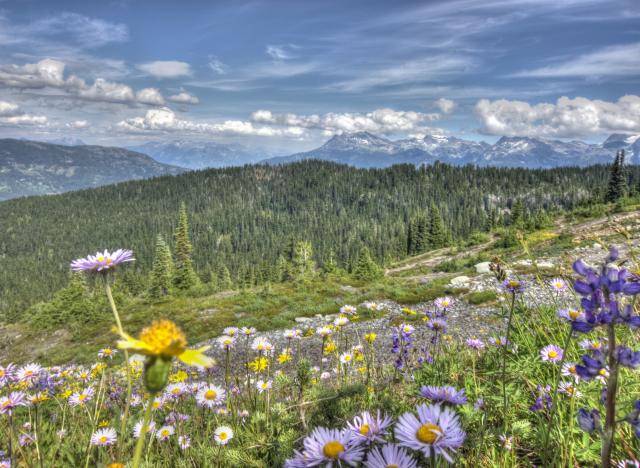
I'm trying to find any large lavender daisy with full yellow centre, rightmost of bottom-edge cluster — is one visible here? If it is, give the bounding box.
[394,404,466,463]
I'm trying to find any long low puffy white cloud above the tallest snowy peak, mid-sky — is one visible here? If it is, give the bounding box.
[251,109,441,134]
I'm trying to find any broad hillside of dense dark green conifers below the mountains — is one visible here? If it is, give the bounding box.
[0,161,640,313]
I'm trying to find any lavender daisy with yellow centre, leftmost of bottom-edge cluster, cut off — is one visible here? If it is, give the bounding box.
[296,427,364,468]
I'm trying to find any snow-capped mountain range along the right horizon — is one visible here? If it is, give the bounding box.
[262,132,640,169]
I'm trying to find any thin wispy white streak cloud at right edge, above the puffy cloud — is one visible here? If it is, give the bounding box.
[513,42,640,78]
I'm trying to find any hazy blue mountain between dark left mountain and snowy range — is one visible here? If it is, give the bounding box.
[129,140,270,169]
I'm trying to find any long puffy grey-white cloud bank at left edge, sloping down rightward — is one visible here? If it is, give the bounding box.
[0,59,164,105]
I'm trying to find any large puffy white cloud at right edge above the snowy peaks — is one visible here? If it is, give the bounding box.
[475,95,640,138]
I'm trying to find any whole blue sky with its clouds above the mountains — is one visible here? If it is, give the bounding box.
[0,0,640,153]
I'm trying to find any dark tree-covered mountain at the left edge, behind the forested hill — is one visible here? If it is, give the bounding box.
[0,139,185,200]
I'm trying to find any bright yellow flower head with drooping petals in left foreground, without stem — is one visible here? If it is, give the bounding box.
[118,320,215,367]
